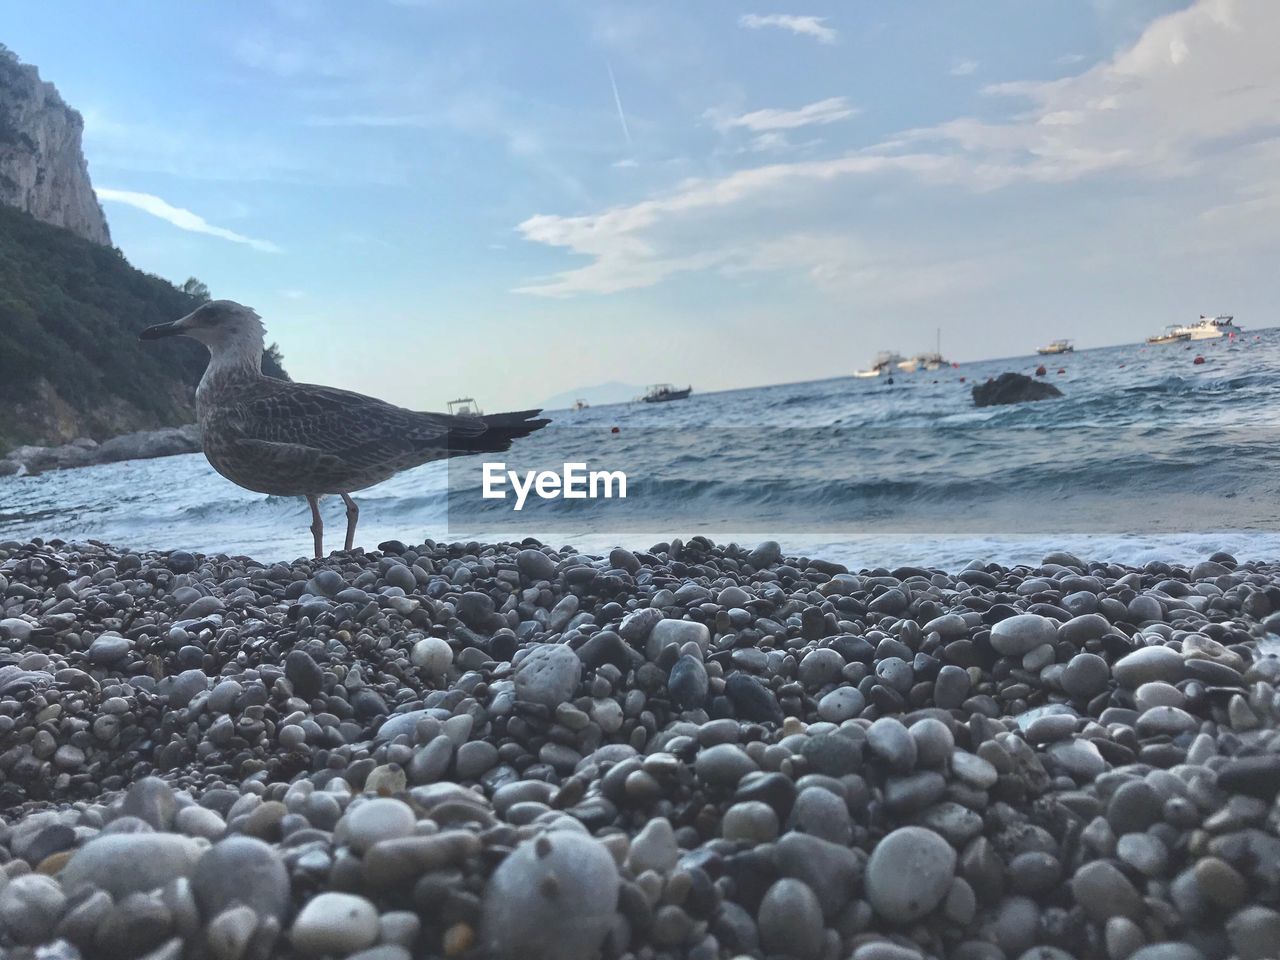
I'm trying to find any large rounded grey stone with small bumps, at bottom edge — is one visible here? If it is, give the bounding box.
[481,831,620,960]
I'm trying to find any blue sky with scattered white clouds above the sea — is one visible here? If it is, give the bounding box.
[0,0,1280,411]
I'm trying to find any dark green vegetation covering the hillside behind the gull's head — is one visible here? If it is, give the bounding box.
[0,205,287,454]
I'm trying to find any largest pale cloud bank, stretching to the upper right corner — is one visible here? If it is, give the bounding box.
[517,0,1280,297]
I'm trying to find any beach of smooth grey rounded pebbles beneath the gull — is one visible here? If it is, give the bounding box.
[0,538,1280,960]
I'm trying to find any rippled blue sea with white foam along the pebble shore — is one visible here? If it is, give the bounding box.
[0,329,1280,570]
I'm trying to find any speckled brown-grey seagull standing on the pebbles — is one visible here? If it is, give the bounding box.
[138,300,550,559]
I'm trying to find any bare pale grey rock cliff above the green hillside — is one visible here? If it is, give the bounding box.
[0,45,111,244]
